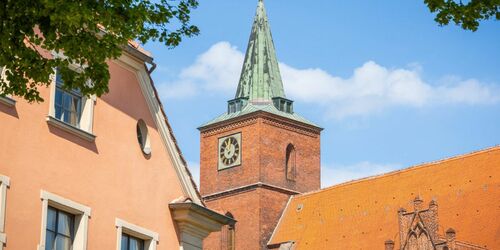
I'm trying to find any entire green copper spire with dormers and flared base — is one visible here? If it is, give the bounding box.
[199,0,319,130]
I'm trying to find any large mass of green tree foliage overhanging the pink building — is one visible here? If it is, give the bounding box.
[0,0,199,102]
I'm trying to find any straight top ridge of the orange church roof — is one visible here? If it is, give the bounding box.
[294,145,500,198]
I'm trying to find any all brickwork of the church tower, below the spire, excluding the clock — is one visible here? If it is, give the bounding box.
[200,112,320,250]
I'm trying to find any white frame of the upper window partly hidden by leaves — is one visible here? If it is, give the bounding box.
[47,65,97,142]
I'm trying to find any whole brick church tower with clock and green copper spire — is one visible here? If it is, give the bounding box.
[199,0,322,250]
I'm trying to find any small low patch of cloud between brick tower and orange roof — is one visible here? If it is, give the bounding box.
[321,161,401,188]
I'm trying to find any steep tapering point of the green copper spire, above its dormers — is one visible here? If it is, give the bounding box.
[235,0,285,102]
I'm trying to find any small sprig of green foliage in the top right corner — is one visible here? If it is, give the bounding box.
[424,0,500,31]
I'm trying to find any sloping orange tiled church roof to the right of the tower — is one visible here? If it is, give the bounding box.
[269,146,500,249]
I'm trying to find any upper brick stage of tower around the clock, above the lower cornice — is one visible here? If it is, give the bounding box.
[200,114,320,196]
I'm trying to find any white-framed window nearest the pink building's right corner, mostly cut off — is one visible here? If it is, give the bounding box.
[115,219,158,250]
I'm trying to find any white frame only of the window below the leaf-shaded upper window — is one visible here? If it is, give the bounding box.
[38,190,91,250]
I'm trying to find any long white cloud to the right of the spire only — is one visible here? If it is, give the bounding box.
[281,61,500,118]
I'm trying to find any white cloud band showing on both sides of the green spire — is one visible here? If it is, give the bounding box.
[159,42,500,118]
